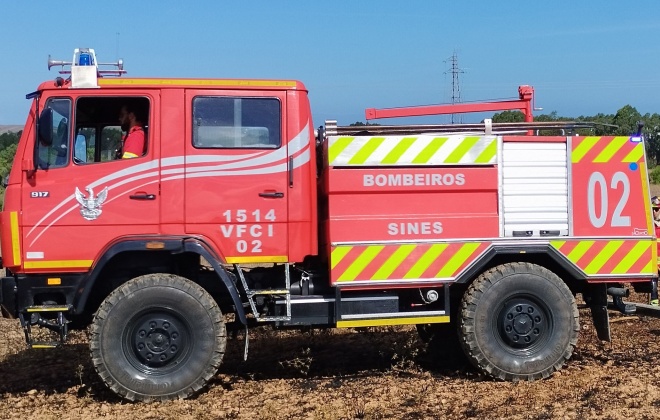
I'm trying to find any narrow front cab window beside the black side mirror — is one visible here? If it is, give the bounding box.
[37,98,71,169]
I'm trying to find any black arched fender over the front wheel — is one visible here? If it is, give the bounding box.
[73,237,247,325]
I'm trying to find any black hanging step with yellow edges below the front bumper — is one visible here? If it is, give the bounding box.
[18,305,73,349]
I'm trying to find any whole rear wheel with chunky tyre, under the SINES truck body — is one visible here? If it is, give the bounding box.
[459,263,580,381]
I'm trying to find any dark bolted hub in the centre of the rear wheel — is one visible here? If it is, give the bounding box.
[501,301,547,348]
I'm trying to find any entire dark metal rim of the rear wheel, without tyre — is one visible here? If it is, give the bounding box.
[494,295,554,354]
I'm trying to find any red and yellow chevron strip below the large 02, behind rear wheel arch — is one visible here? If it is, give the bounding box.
[550,240,657,275]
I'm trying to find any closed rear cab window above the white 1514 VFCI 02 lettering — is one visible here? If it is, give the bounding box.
[192,96,282,149]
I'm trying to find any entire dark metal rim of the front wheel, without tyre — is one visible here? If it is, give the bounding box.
[123,309,192,375]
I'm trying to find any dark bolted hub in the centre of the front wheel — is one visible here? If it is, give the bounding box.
[134,317,182,366]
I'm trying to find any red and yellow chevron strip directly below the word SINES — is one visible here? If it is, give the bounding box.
[330,242,490,284]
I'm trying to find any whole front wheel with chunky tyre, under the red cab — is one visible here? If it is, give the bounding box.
[90,274,227,401]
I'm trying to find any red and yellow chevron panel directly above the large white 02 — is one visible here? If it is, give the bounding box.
[571,136,644,163]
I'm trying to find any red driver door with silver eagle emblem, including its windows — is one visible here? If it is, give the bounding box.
[21,93,161,271]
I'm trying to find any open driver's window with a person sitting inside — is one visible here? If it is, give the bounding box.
[73,96,150,165]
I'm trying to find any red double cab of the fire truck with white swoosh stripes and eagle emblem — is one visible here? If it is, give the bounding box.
[2,49,317,313]
